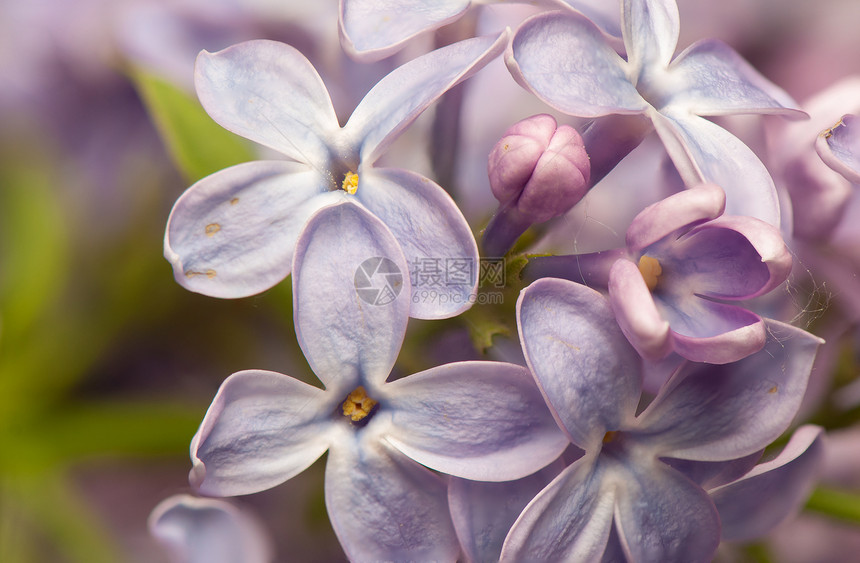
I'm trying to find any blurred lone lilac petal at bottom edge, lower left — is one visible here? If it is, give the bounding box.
[149,495,273,563]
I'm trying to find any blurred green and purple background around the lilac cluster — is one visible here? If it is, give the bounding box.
[0,0,860,563]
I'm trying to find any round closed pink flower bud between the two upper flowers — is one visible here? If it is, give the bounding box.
[487,114,591,223]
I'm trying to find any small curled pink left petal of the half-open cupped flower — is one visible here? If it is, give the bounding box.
[609,259,672,361]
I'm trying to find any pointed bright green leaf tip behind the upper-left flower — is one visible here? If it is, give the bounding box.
[130,68,255,182]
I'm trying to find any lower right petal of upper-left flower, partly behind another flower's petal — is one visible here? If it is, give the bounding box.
[356,167,480,319]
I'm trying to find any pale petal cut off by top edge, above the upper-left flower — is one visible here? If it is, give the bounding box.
[340,0,472,61]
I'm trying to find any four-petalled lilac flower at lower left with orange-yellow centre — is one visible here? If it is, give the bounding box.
[190,201,567,560]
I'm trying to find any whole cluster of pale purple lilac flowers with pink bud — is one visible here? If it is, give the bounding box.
[148,0,860,562]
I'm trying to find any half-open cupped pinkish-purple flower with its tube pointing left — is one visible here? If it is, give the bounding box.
[529,184,792,363]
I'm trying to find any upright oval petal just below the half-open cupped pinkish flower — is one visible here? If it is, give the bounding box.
[517,278,641,449]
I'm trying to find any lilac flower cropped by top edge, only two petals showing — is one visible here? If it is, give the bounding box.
[338,0,620,61]
